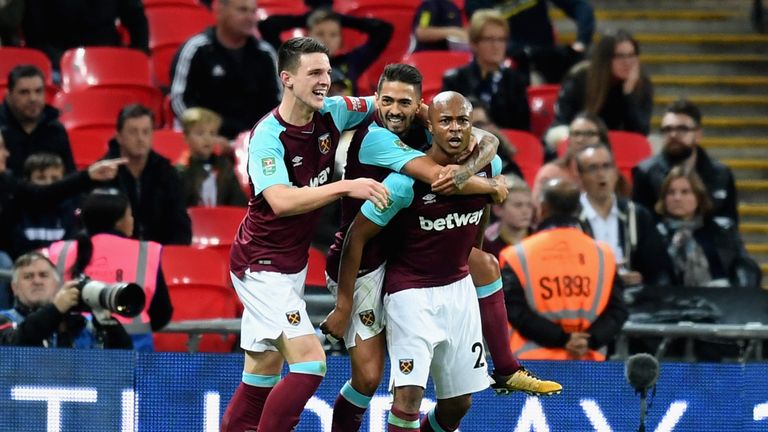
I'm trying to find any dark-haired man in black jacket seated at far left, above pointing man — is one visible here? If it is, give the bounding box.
[0,65,75,176]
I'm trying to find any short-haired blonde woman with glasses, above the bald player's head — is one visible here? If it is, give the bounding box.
[443,10,531,131]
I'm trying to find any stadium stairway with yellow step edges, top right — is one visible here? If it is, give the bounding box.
[551,0,768,289]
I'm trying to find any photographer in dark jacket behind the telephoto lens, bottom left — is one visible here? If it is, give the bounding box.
[0,252,133,349]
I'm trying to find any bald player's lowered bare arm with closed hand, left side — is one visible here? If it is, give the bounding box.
[320,213,382,339]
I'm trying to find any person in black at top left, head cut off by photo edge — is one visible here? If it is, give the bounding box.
[23,0,149,69]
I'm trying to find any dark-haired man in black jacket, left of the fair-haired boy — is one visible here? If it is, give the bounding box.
[101,105,192,245]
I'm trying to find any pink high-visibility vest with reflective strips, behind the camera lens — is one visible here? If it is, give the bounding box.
[48,234,162,335]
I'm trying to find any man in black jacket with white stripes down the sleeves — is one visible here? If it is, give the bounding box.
[170,0,281,139]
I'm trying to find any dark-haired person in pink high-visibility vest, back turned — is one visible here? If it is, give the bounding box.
[49,189,173,351]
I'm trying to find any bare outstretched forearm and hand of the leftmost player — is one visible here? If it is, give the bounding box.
[262,178,389,217]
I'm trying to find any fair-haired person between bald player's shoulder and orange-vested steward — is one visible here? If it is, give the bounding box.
[483,174,534,258]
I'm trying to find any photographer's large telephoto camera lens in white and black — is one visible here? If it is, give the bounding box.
[77,275,146,318]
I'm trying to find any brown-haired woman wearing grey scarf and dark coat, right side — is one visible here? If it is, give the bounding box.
[656,166,760,287]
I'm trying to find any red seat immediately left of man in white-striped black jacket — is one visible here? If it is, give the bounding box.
[145,6,216,87]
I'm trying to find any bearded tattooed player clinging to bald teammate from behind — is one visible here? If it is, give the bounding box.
[321,64,560,432]
